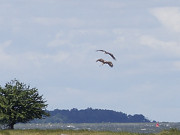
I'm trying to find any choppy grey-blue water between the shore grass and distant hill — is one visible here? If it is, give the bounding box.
[15,123,180,133]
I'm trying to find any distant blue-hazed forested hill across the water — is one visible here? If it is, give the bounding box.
[32,108,150,123]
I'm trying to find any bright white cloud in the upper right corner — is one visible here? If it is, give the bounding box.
[151,7,180,32]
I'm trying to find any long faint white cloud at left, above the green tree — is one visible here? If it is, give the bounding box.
[0,40,69,70]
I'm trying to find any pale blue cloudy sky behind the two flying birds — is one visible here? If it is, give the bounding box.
[0,0,180,122]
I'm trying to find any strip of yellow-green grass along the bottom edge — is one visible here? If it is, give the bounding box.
[0,129,180,135]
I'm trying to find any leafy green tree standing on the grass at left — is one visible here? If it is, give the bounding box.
[0,79,49,129]
